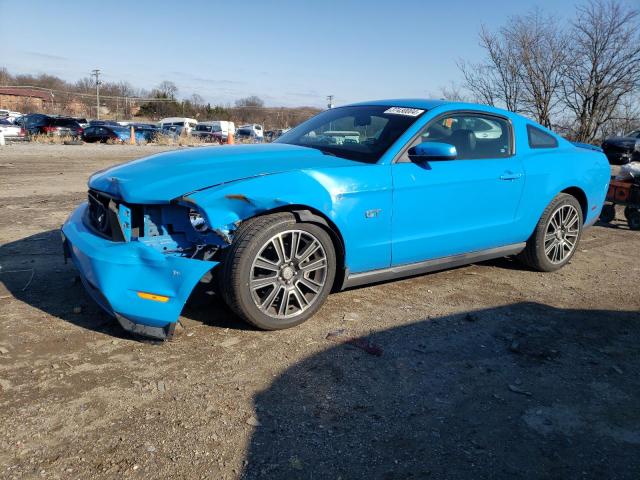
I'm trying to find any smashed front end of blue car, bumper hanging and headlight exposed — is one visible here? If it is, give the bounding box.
[62,189,231,339]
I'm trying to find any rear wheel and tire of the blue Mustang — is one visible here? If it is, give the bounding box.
[519,193,584,272]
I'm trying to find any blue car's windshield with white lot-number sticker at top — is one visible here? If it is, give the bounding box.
[275,106,424,163]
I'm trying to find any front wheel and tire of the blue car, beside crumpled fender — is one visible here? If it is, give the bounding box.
[218,213,336,330]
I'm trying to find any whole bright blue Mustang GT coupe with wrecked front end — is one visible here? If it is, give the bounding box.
[62,100,610,339]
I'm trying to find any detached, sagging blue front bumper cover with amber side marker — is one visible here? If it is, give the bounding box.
[62,202,218,339]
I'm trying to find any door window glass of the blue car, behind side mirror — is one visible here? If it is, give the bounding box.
[399,113,513,162]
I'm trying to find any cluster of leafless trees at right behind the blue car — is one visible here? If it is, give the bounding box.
[458,0,640,143]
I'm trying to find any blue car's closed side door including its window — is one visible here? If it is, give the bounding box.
[392,112,525,265]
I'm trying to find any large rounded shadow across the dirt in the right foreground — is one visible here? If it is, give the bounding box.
[243,303,640,480]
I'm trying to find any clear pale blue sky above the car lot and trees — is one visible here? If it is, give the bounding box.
[0,0,620,107]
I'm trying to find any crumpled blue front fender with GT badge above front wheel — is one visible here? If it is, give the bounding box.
[181,165,391,271]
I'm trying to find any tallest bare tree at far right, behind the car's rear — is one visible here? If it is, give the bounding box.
[564,0,640,142]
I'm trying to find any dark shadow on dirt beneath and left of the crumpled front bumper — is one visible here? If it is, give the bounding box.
[0,230,245,339]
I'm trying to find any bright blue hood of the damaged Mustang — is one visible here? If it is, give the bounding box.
[89,143,360,203]
